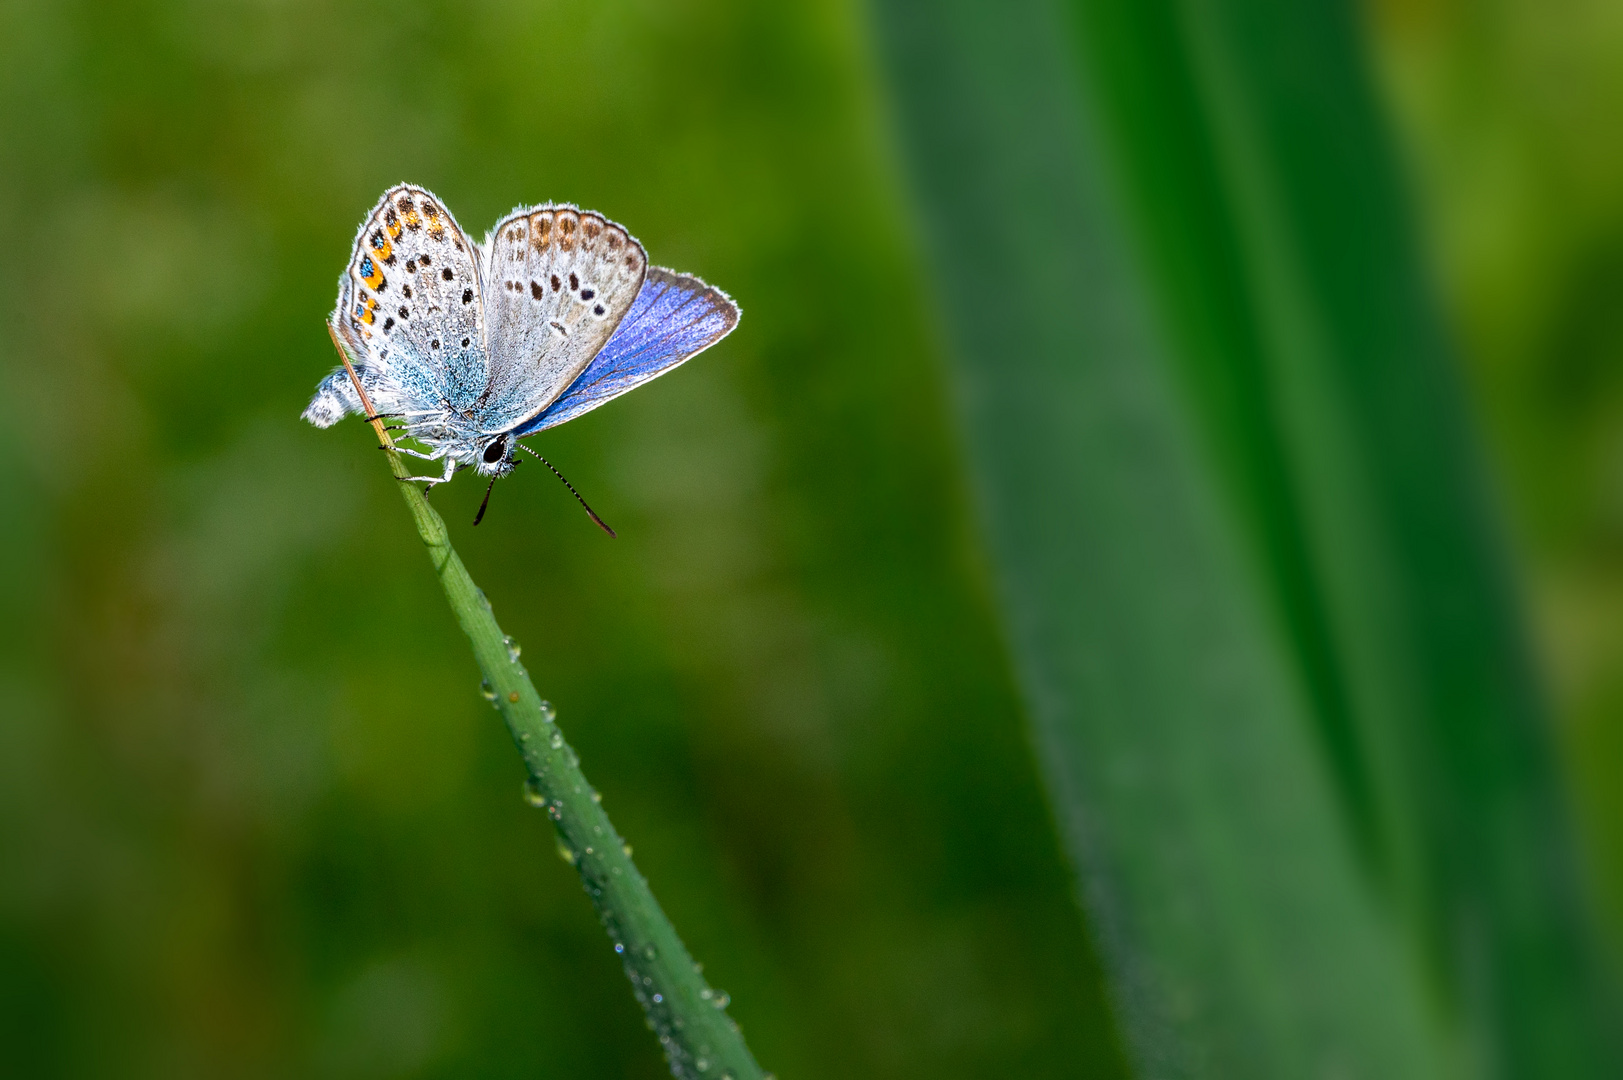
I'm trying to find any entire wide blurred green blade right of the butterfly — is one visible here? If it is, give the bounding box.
[875,0,1605,1077]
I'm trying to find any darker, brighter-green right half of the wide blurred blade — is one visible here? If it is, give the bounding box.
[1078,0,1615,1077]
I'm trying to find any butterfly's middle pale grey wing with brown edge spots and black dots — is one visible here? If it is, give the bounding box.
[482,206,648,430]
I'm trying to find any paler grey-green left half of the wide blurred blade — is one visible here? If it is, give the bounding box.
[880,3,1440,1077]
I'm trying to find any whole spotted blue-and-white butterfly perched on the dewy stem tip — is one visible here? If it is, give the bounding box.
[304,184,738,534]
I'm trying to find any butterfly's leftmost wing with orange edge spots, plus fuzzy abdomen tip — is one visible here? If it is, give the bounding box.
[304,184,487,427]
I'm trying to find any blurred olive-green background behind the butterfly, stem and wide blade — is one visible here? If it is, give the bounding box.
[0,0,1623,1080]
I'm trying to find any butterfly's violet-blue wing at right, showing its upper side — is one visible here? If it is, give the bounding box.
[518,266,738,435]
